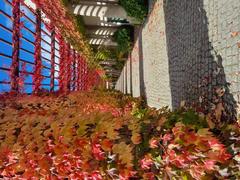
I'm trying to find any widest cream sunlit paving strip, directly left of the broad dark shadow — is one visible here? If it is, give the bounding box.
[140,1,172,108]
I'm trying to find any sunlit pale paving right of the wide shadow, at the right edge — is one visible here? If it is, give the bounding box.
[204,0,240,111]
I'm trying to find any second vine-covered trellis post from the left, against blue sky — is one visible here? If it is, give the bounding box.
[33,9,43,93]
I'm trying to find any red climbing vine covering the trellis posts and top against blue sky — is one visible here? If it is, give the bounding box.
[10,0,99,93]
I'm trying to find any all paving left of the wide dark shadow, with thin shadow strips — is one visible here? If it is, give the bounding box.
[116,1,172,108]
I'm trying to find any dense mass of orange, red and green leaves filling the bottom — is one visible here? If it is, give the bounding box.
[0,91,240,180]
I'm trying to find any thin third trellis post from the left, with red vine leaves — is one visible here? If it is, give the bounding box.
[50,27,55,92]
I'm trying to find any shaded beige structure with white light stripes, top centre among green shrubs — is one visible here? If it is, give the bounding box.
[69,0,134,81]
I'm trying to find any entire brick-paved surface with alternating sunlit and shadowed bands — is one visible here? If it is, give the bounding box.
[115,0,240,113]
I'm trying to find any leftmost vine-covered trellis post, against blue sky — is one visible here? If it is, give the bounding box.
[10,0,21,92]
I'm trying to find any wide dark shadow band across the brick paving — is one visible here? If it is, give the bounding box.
[164,0,237,122]
